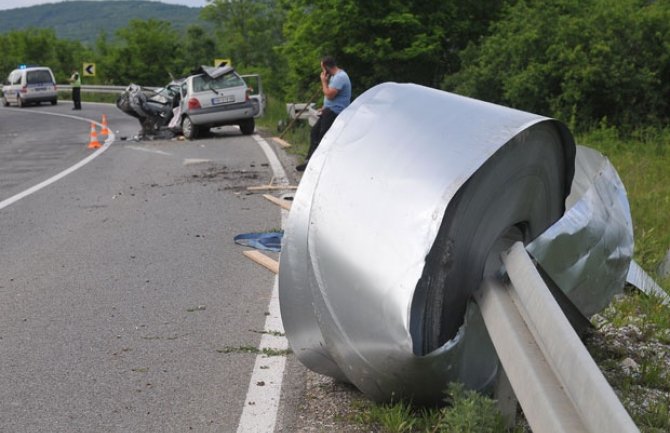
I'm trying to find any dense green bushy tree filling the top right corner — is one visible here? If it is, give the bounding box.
[443,0,670,126]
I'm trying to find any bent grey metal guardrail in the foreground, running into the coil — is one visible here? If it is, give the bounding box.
[476,242,639,433]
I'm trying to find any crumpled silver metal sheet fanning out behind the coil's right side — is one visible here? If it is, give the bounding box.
[526,146,633,317]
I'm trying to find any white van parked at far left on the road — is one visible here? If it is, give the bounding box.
[2,66,58,107]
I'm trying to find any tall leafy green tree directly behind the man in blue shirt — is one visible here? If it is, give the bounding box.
[280,0,505,96]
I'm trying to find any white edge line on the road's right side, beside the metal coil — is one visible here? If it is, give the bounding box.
[237,134,288,433]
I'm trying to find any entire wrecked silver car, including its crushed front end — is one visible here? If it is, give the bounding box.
[117,65,265,139]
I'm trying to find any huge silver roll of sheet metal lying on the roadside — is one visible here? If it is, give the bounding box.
[279,83,575,403]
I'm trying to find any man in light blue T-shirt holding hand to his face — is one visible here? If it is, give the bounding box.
[295,56,351,171]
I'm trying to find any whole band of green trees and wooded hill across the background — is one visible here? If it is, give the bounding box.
[0,0,670,130]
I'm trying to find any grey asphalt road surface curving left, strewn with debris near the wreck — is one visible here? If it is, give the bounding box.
[0,103,299,433]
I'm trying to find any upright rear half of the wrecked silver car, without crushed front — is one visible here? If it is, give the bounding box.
[180,66,264,139]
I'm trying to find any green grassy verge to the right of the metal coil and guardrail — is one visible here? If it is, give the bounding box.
[577,124,670,433]
